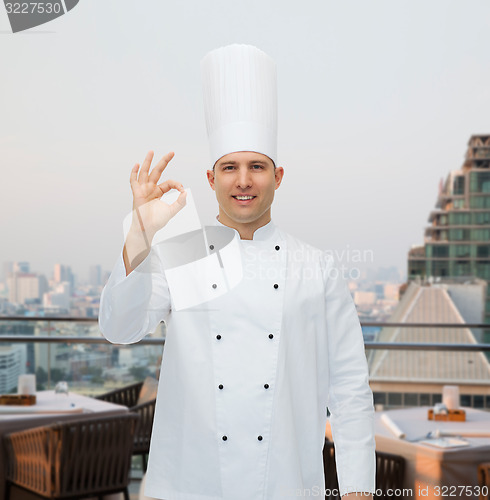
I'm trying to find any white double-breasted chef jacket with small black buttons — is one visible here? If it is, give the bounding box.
[99,221,375,500]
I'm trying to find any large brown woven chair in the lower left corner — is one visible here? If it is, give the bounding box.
[4,413,139,500]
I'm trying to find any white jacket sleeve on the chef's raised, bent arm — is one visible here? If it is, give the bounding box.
[99,246,170,344]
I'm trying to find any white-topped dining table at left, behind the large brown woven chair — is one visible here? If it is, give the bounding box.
[0,391,129,500]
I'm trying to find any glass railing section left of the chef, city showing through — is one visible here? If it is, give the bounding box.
[0,317,165,396]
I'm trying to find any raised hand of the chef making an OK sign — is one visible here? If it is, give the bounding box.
[123,151,187,275]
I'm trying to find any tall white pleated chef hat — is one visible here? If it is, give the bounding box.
[201,44,277,165]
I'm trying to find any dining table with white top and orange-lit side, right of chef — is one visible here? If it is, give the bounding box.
[325,406,490,500]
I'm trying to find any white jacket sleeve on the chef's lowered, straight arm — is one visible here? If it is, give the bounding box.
[325,254,376,495]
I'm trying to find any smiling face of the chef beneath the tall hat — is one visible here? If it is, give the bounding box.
[207,151,284,233]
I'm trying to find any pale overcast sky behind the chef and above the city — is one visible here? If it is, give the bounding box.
[0,0,490,278]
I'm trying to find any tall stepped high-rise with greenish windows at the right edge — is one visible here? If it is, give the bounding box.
[408,135,490,328]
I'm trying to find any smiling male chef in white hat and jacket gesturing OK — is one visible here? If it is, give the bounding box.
[99,44,375,500]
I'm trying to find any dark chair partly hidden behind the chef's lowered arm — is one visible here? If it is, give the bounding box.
[323,439,405,500]
